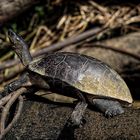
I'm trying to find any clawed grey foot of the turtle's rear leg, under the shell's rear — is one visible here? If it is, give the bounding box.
[105,107,124,118]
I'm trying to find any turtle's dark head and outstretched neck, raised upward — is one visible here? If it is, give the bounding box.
[8,29,32,66]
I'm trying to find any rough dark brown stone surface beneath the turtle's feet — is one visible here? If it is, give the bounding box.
[5,101,140,140]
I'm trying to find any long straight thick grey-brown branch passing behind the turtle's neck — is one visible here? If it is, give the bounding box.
[0,27,107,70]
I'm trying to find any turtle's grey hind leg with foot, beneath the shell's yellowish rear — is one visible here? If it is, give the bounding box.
[92,99,124,118]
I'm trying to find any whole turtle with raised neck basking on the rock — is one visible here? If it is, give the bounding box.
[4,29,133,125]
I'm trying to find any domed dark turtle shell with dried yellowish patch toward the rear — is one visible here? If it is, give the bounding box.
[28,52,133,103]
